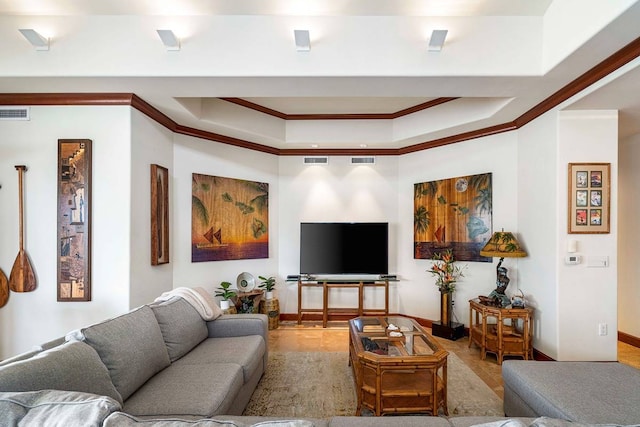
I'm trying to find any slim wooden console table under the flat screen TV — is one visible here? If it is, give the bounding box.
[298,279,389,328]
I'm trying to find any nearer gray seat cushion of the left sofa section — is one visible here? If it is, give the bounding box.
[124,363,243,417]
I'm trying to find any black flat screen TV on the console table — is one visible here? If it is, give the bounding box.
[300,222,389,275]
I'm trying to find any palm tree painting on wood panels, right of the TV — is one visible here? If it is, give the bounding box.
[413,173,493,262]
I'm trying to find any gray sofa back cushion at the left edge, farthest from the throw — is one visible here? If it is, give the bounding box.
[0,342,122,403]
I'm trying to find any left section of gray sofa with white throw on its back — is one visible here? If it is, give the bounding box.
[0,297,268,419]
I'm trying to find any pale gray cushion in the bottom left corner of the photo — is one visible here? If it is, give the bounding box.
[0,390,121,427]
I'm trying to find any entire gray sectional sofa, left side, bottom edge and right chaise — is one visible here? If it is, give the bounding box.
[0,297,640,427]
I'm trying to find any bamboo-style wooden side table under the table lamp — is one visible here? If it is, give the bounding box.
[469,299,533,365]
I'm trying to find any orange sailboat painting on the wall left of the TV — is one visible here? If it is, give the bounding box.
[191,173,269,262]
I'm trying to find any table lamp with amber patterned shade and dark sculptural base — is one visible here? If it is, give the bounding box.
[480,230,527,307]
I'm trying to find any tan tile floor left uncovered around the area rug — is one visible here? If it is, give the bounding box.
[269,322,640,399]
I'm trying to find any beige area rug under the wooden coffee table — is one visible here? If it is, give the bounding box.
[244,352,503,418]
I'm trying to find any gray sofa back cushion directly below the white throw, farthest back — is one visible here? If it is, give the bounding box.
[151,297,209,362]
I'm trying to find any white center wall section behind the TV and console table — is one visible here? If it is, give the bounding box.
[278,156,400,313]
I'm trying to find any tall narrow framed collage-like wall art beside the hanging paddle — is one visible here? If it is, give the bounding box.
[58,139,91,301]
